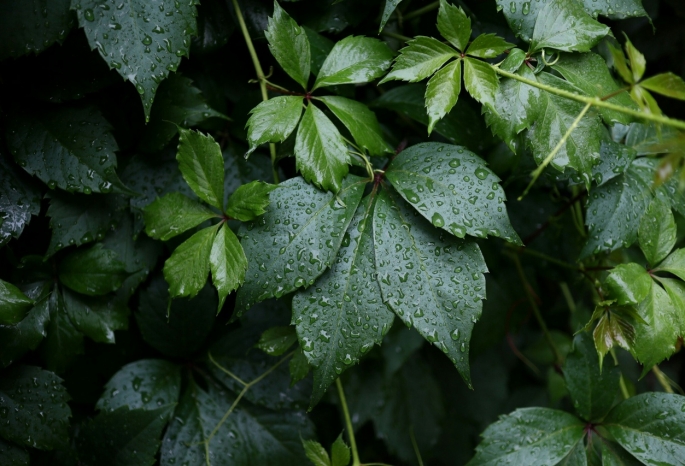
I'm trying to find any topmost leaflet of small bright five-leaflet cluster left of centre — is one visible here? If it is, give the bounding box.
[176,128,224,210]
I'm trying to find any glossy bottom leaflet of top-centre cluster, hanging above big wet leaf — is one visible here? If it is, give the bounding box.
[295,103,350,193]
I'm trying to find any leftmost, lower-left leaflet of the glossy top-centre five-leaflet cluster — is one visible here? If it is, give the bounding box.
[247,95,302,155]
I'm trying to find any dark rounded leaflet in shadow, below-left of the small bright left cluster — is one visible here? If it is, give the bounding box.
[59,243,126,296]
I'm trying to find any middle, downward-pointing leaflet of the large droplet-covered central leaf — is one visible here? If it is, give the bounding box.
[292,194,394,407]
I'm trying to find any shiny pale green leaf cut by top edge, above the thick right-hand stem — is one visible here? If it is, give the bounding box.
[531,0,610,52]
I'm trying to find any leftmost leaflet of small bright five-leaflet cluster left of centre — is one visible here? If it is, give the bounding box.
[143,192,217,241]
